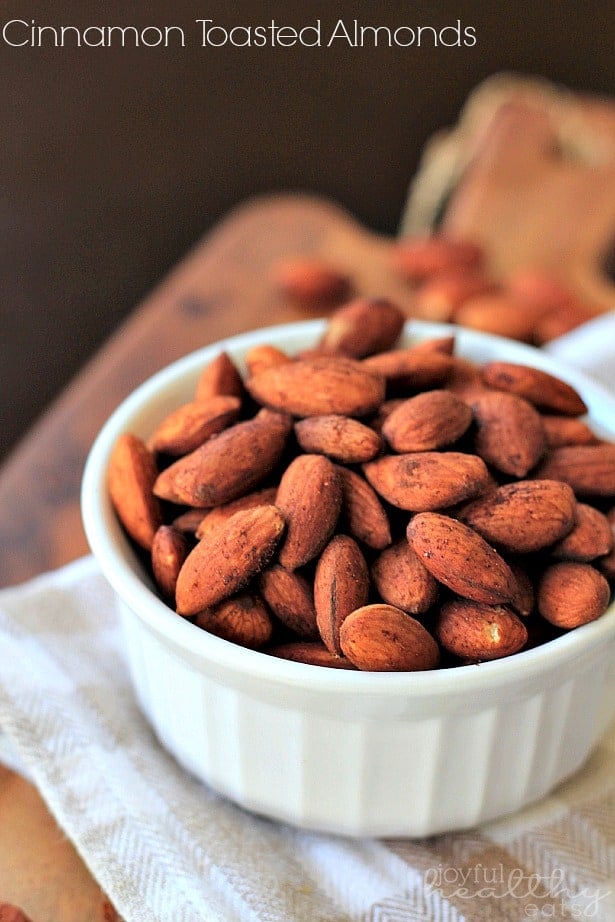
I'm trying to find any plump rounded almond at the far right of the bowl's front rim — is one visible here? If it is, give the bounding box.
[537,561,611,629]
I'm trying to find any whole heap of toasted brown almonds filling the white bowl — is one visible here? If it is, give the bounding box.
[108,299,615,671]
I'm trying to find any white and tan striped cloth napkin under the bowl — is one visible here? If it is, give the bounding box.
[0,314,615,922]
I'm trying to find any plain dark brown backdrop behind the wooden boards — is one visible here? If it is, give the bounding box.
[0,0,615,455]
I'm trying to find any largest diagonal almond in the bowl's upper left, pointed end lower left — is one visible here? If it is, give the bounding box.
[154,410,292,508]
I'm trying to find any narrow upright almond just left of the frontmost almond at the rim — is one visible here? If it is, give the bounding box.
[314,535,369,656]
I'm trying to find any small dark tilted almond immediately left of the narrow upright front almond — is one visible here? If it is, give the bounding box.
[258,563,319,640]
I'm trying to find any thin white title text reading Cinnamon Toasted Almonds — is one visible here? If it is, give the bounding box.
[0,18,477,49]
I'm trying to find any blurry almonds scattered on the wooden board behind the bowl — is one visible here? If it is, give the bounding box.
[274,234,597,346]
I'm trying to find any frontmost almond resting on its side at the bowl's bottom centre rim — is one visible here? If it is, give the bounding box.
[340,604,440,672]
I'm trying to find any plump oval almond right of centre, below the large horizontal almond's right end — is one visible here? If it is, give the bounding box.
[382,390,472,450]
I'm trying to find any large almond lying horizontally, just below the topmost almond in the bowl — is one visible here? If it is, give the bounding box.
[247,356,384,416]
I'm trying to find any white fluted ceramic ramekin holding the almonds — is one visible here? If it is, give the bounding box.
[82,321,615,836]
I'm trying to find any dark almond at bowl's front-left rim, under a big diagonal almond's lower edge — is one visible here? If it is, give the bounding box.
[195,593,273,650]
